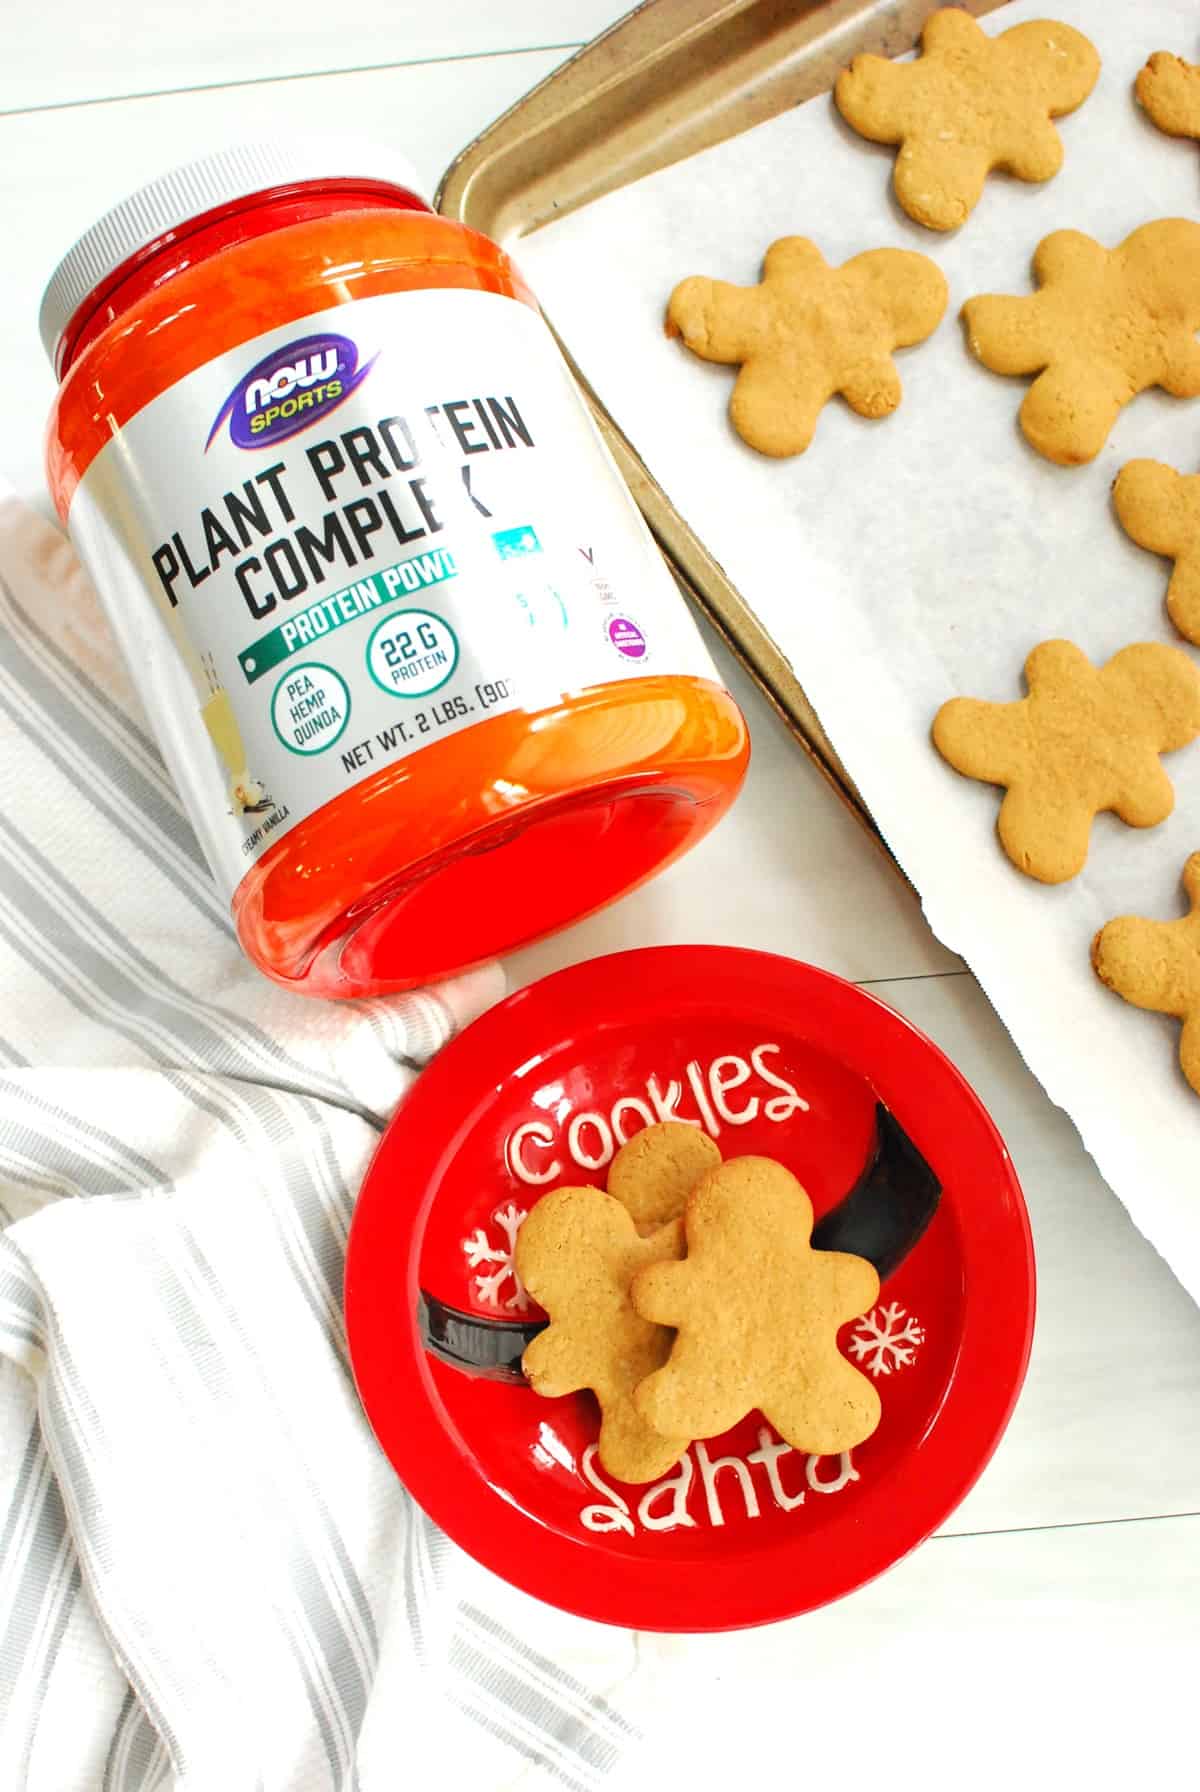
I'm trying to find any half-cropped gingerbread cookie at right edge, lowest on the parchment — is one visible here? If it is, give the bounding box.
[1093,853,1200,1095]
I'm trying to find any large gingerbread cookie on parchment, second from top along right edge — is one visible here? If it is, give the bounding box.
[962,219,1200,466]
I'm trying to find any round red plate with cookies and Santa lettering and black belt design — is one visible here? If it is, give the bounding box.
[346,946,1033,1631]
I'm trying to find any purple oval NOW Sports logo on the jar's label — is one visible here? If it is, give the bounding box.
[204,335,376,453]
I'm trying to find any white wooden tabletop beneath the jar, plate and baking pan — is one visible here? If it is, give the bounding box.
[0,0,1200,1792]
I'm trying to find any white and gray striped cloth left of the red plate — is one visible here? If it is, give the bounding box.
[0,493,638,1792]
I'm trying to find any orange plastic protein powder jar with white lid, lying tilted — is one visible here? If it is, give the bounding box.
[41,145,749,996]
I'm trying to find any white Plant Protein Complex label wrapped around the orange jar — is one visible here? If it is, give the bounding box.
[68,290,716,894]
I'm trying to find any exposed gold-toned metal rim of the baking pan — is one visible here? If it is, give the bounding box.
[435,0,1008,831]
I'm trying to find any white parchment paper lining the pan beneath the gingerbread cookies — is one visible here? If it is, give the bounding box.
[519,0,1200,1299]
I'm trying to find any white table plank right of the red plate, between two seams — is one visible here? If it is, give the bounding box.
[874,975,1200,1532]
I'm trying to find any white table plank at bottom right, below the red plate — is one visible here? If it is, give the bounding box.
[625,1518,1200,1792]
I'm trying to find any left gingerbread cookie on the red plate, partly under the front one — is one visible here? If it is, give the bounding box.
[516,1188,691,1482]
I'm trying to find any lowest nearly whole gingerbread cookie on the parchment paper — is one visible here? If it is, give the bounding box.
[933,642,1200,883]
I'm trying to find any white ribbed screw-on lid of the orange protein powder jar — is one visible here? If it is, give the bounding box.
[38,138,428,371]
